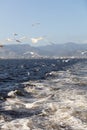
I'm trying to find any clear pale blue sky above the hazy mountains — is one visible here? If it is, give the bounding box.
[0,0,87,45]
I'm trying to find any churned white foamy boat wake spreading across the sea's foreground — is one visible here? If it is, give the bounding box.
[0,61,87,130]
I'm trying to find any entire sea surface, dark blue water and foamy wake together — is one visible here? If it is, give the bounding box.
[0,59,87,130]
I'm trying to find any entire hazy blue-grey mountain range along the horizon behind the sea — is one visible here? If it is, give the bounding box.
[0,42,87,59]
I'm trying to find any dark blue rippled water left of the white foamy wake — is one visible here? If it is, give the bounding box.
[0,59,82,95]
